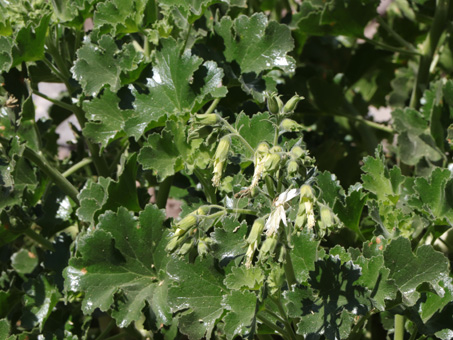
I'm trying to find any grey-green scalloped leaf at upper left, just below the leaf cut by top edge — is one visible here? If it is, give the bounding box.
[71,35,141,97]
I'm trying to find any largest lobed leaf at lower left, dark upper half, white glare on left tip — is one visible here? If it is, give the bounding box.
[65,205,169,327]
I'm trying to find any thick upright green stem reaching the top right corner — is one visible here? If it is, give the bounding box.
[410,0,450,109]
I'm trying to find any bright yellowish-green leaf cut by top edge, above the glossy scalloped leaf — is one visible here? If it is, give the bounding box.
[93,0,146,35]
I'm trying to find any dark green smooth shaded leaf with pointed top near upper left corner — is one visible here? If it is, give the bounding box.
[12,14,50,67]
